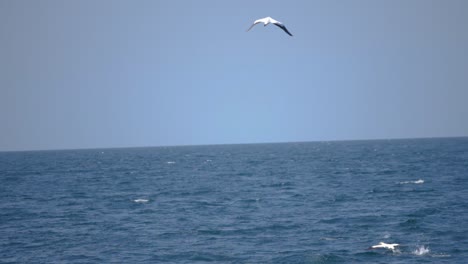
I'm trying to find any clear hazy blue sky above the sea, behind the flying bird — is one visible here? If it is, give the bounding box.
[0,0,468,150]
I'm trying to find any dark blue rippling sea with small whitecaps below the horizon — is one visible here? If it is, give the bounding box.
[0,138,468,263]
